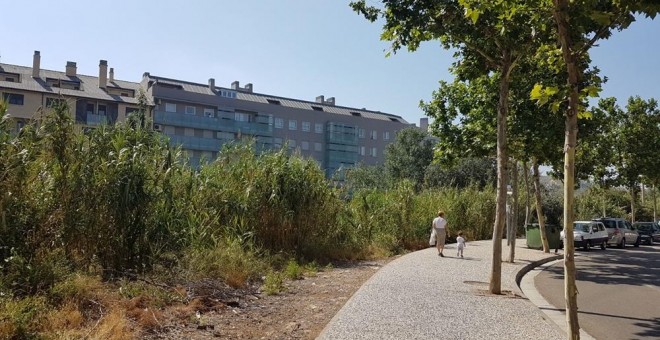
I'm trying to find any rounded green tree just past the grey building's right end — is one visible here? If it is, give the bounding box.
[385,127,433,190]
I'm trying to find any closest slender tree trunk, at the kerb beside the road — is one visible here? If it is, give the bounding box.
[553,0,581,339]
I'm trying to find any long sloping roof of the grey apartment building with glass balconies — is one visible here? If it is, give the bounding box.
[145,73,409,124]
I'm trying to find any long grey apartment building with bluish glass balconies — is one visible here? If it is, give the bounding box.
[141,73,410,176]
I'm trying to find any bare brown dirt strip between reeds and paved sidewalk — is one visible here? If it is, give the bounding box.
[141,259,391,339]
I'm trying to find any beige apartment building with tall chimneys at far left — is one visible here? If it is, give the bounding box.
[0,51,140,131]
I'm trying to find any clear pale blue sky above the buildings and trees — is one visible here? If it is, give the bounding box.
[0,0,660,123]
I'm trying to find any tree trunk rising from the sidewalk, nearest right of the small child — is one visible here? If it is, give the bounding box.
[488,50,511,294]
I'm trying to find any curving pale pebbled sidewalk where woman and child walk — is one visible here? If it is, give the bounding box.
[317,239,566,340]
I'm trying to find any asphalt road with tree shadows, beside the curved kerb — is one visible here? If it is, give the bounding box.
[534,245,660,339]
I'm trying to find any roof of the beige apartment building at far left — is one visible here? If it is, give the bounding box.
[0,63,140,104]
